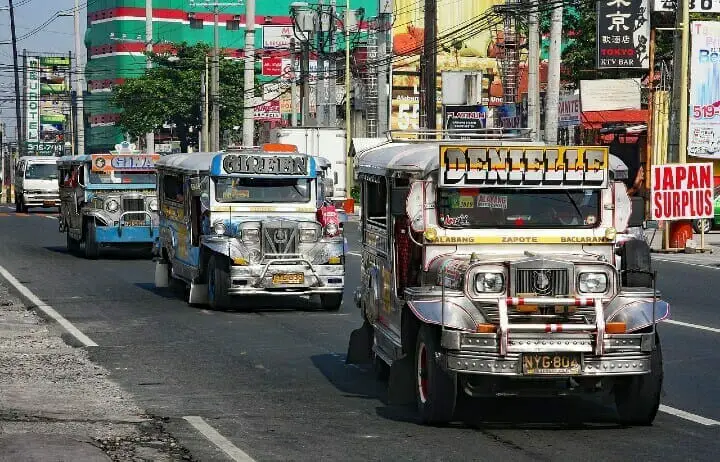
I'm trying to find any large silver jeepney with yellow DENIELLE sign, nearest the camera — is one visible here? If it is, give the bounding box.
[347,134,669,425]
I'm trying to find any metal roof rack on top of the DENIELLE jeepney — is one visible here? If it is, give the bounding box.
[387,128,532,142]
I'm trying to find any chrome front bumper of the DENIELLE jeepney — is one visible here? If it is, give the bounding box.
[441,330,655,378]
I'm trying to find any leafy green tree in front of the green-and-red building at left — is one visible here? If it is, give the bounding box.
[112,44,250,151]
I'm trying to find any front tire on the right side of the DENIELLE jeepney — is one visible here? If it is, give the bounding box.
[614,334,664,426]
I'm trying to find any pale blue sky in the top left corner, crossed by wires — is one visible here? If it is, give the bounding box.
[0,0,80,140]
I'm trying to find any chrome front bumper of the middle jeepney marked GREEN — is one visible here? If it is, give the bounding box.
[229,259,345,296]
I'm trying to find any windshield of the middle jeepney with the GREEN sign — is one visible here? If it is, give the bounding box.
[215,177,310,202]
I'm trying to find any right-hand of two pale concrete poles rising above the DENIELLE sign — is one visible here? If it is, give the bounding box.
[545,4,563,145]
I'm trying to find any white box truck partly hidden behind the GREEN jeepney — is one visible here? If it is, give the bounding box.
[270,127,350,204]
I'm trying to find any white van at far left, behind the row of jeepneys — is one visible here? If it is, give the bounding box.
[15,156,60,213]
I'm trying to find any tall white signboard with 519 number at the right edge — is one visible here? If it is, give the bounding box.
[688,21,720,158]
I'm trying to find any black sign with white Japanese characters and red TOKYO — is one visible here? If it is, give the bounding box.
[597,0,650,69]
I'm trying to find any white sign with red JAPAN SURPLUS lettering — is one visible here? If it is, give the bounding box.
[651,163,714,221]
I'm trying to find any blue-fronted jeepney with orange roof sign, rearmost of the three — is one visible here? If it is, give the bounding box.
[57,147,160,259]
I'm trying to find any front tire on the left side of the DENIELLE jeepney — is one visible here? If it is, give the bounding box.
[415,324,458,424]
